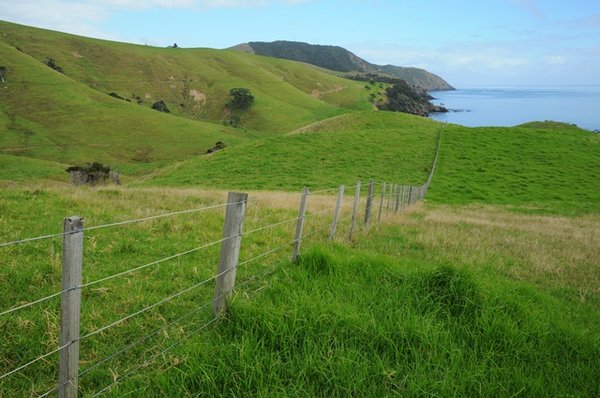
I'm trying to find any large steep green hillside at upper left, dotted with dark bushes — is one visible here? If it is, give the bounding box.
[0,22,372,178]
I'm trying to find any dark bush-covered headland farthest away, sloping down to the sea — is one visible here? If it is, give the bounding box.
[232,40,453,91]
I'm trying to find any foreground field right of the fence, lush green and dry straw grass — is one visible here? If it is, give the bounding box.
[103,206,600,397]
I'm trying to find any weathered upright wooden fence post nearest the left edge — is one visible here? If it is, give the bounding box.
[58,216,83,398]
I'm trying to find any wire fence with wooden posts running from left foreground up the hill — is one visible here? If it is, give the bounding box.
[0,130,441,397]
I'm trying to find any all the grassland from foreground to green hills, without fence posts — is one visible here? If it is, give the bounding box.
[0,22,600,398]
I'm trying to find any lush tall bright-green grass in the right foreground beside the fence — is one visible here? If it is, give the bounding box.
[114,239,600,397]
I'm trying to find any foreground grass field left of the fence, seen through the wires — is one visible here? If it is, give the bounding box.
[0,185,350,397]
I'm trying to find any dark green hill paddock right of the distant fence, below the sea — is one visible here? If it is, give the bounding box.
[429,122,600,214]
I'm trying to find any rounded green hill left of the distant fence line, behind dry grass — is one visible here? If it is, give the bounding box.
[145,112,440,190]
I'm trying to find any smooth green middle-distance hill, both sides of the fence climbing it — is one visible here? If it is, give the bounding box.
[146,112,600,213]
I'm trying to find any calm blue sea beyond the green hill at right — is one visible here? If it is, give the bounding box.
[430,86,600,130]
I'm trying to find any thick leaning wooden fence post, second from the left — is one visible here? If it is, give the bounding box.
[213,192,248,317]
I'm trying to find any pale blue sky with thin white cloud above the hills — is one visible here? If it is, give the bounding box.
[0,0,600,88]
